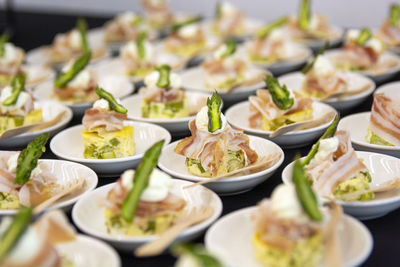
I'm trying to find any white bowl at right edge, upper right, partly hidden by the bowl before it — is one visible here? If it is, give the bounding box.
[324,49,400,84]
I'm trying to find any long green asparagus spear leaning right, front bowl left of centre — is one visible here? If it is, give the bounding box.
[121,140,164,222]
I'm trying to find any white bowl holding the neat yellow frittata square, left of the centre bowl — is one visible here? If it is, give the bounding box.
[50,121,171,176]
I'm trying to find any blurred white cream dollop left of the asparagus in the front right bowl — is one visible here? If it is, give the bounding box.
[271,184,309,223]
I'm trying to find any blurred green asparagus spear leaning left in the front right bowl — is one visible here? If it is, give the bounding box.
[293,159,323,222]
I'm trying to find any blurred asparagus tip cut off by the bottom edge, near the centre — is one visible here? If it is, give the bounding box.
[171,244,222,267]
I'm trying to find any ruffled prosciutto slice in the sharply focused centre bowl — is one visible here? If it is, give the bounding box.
[174,120,258,176]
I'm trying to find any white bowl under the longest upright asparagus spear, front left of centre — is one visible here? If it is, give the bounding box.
[72,179,222,252]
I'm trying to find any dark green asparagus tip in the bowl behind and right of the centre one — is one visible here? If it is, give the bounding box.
[265,75,294,110]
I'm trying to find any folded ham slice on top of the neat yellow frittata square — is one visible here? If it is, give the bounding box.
[82,108,128,132]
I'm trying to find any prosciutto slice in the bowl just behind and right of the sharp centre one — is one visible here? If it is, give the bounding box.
[249,89,312,128]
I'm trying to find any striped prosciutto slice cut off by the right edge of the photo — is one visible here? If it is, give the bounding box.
[369,94,400,146]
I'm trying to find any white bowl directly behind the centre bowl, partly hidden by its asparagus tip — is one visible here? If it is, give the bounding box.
[181,67,268,106]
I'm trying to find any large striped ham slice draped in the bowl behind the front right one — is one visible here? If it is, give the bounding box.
[305,131,368,197]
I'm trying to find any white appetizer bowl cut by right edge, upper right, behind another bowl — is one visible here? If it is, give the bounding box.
[325,49,400,84]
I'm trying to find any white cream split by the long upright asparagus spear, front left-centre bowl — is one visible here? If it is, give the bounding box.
[121,169,172,202]
